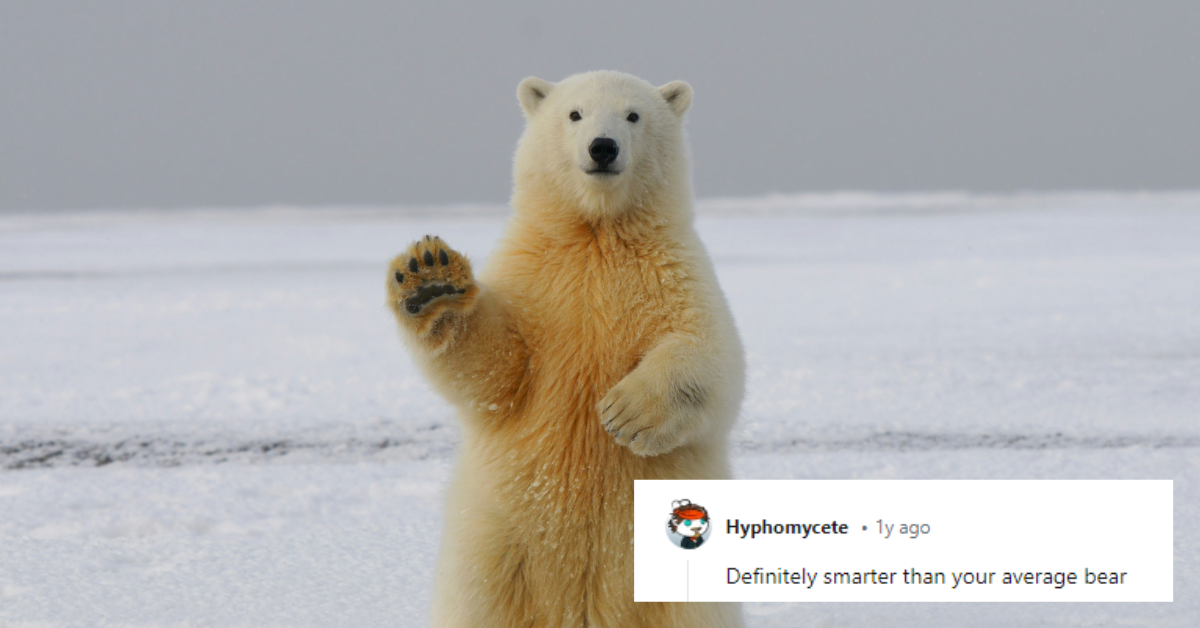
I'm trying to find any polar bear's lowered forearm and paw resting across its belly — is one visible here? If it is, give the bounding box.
[596,335,728,456]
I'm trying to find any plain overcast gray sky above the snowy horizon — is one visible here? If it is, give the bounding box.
[0,0,1200,209]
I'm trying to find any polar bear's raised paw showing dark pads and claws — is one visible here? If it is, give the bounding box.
[388,235,476,318]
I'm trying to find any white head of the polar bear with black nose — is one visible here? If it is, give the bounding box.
[515,72,692,220]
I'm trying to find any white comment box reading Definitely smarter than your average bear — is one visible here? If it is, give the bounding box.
[634,480,1174,602]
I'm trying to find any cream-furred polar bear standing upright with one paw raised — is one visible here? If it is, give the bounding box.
[388,72,744,628]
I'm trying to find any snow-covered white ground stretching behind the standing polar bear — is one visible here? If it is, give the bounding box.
[0,193,1200,627]
